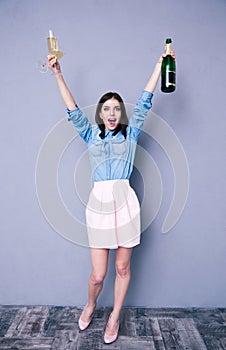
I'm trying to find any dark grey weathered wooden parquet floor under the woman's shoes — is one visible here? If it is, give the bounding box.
[0,306,226,350]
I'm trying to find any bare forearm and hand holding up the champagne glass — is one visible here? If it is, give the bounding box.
[48,55,77,111]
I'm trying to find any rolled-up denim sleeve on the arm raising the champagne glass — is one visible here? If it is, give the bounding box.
[67,107,92,142]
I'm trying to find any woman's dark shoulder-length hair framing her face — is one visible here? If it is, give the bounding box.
[95,92,129,139]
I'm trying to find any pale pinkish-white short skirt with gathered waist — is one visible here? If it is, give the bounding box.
[86,180,141,249]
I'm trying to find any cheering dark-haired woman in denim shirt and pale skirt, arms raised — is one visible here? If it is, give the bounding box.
[48,51,175,344]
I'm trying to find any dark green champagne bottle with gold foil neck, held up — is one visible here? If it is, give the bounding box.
[161,38,176,92]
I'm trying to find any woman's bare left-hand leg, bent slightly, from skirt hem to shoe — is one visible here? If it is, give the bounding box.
[81,248,109,322]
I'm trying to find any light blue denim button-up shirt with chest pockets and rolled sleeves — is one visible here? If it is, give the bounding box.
[67,90,153,182]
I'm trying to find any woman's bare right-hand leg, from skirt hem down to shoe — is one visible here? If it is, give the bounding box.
[106,247,132,335]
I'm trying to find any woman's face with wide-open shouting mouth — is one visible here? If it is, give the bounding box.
[100,97,121,131]
